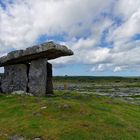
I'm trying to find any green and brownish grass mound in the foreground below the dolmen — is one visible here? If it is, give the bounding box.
[0,91,140,140]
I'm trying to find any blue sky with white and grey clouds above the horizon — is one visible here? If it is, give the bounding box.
[0,0,140,76]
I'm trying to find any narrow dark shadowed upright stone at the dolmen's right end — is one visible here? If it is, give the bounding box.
[47,63,53,94]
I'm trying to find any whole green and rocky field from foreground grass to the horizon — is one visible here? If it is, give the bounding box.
[0,76,140,140]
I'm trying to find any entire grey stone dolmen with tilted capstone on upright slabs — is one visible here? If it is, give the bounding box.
[0,42,73,96]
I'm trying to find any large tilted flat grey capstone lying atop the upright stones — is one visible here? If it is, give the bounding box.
[0,42,73,67]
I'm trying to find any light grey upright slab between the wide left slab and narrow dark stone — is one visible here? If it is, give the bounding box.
[28,59,47,96]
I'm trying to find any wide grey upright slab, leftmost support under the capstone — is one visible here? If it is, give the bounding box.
[1,64,28,93]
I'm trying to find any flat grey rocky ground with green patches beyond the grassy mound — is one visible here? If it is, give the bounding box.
[54,77,140,105]
